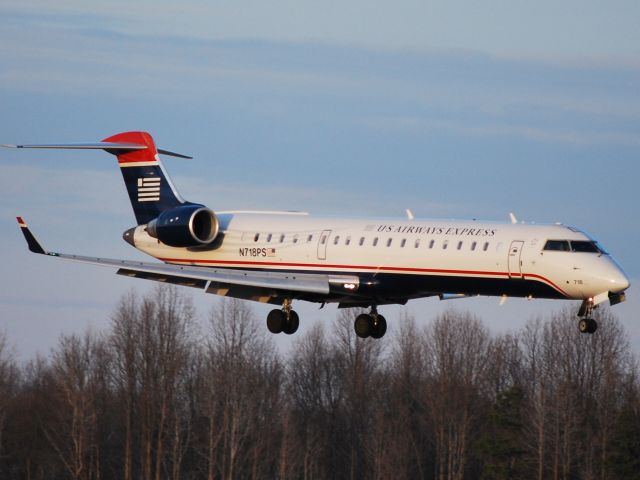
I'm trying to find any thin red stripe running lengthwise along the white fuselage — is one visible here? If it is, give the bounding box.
[158,258,569,297]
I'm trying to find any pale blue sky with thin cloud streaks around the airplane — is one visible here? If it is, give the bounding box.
[0,0,640,356]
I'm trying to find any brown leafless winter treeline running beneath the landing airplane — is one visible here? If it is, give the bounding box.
[0,287,640,480]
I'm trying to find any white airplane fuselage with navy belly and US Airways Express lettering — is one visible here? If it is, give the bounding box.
[134,212,629,303]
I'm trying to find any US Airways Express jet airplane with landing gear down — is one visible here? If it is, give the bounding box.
[3,132,630,339]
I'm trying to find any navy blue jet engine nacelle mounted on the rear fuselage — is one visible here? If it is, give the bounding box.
[147,205,220,247]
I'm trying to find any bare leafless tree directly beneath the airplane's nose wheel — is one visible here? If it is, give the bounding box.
[521,309,633,479]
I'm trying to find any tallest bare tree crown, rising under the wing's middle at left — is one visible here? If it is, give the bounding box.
[111,286,194,480]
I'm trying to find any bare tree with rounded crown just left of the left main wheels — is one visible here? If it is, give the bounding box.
[200,299,282,479]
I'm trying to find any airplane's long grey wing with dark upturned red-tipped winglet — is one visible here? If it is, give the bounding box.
[17,217,359,302]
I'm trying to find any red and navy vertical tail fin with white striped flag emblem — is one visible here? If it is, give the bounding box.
[103,132,189,225]
